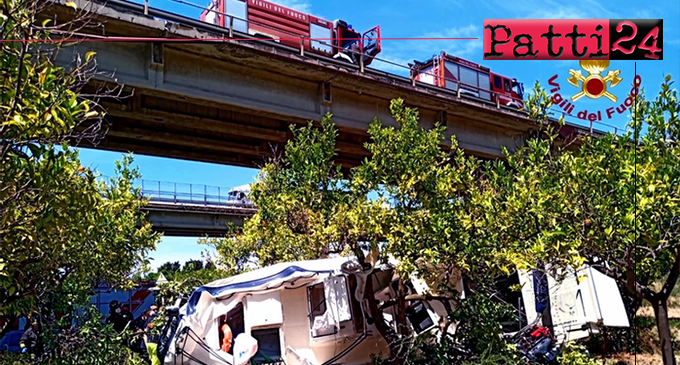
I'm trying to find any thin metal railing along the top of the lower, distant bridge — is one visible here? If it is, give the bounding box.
[139,180,253,208]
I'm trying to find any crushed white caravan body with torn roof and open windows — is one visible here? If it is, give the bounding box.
[162,257,462,365]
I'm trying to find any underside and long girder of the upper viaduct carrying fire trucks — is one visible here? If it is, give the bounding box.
[43,0,600,167]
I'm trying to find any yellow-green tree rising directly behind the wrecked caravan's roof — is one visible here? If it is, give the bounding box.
[210,116,359,272]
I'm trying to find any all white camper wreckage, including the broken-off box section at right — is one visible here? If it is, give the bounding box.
[153,255,628,365]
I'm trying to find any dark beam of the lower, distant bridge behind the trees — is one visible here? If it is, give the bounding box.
[143,202,255,237]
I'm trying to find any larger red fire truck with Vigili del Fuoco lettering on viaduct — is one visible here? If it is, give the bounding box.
[201,0,381,66]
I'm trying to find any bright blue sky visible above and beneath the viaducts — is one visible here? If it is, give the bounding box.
[75,0,680,267]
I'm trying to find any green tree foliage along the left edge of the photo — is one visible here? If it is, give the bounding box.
[0,0,159,315]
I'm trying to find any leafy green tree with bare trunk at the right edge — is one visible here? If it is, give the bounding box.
[490,77,680,364]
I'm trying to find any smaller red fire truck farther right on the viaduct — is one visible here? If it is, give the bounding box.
[409,52,524,109]
